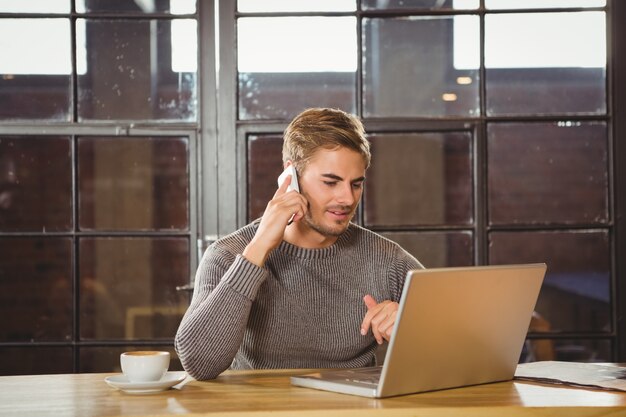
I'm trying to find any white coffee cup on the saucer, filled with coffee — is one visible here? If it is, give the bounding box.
[120,350,170,382]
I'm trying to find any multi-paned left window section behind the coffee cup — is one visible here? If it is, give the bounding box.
[0,0,197,374]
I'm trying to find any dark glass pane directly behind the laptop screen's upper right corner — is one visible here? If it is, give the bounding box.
[489,230,611,332]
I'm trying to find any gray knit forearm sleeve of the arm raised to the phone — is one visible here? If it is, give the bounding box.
[174,247,268,380]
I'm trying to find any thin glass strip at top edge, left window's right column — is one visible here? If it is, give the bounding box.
[76,0,196,14]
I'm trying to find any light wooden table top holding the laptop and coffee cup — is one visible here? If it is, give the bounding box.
[0,370,626,417]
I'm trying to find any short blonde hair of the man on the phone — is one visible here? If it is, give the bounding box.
[283,108,372,172]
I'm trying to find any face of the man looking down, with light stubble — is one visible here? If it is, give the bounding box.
[298,148,365,237]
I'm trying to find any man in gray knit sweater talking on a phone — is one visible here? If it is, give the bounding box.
[175,109,422,379]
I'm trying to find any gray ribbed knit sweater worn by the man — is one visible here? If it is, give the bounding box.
[175,221,423,380]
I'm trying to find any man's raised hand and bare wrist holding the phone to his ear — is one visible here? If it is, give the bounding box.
[243,175,307,266]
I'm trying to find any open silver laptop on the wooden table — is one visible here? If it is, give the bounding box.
[291,263,546,398]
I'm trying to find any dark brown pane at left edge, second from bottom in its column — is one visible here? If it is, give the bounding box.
[0,237,73,342]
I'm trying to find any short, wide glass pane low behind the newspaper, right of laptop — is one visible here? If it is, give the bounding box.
[521,339,613,362]
